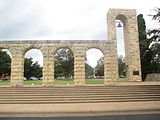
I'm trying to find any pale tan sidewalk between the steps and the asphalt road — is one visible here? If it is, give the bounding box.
[0,101,160,117]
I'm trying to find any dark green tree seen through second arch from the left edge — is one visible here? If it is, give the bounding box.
[24,58,42,80]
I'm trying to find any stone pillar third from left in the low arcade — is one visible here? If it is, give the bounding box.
[74,50,85,86]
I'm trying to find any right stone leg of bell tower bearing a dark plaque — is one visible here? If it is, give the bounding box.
[126,14,142,81]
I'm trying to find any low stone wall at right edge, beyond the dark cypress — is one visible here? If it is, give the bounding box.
[145,73,160,81]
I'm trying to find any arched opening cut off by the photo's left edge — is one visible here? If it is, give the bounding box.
[0,49,12,85]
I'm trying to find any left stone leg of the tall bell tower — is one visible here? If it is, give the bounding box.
[105,10,119,84]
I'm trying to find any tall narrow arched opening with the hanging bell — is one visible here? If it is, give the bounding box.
[115,15,127,81]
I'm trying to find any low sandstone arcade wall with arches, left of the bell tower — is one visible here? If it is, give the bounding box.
[0,40,113,87]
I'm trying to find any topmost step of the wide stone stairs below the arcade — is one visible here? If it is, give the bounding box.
[0,88,160,94]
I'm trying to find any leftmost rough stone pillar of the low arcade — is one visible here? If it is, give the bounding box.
[10,46,24,87]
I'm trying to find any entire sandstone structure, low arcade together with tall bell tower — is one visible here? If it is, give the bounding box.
[0,9,141,87]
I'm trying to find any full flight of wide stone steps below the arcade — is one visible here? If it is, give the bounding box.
[0,86,160,104]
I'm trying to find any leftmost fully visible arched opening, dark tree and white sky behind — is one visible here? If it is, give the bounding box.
[23,49,43,85]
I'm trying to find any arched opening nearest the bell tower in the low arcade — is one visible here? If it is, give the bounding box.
[85,48,104,84]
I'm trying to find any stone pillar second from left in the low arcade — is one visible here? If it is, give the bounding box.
[43,47,54,87]
